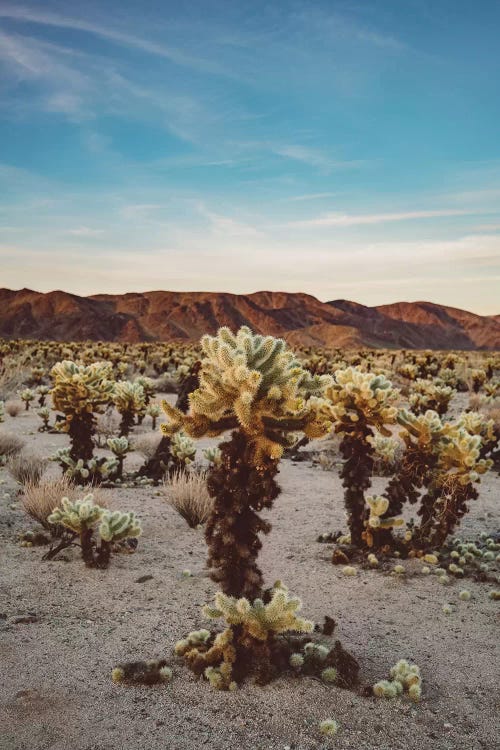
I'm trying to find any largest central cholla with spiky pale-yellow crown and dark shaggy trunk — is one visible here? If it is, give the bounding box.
[161,327,330,599]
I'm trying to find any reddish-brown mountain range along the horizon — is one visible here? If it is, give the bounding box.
[0,289,500,350]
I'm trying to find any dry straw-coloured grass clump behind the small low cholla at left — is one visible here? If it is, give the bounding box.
[21,476,109,533]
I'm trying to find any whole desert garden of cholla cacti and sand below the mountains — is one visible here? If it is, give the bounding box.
[0,336,500,750]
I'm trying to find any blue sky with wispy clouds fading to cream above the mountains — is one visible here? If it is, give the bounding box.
[0,0,500,314]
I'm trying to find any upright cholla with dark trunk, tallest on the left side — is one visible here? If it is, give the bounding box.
[51,360,114,461]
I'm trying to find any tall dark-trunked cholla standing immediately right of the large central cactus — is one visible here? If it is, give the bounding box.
[325,367,399,547]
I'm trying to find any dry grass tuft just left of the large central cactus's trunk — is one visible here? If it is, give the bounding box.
[163,470,213,529]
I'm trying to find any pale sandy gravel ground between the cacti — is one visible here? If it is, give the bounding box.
[0,394,500,750]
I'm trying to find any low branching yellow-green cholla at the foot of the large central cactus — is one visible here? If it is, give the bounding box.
[175,582,314,690]
